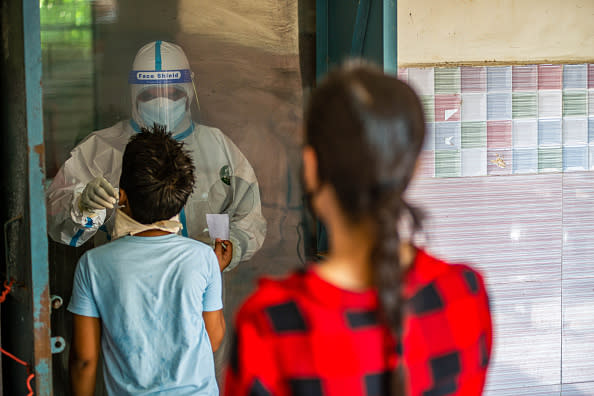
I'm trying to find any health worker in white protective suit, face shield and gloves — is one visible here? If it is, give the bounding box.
[47,41,266,270]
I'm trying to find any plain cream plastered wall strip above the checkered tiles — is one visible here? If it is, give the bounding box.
[398,0,594,67]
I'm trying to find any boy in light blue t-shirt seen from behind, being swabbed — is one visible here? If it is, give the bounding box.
[68,126,232,396]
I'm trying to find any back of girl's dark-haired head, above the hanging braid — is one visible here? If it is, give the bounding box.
[305,66,425,222]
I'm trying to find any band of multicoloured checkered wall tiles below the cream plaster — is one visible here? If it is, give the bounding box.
[398,64,594,177]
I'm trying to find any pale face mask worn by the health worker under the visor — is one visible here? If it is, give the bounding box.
[138,98,187,132]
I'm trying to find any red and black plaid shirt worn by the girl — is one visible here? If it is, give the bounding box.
[225,250,492,396]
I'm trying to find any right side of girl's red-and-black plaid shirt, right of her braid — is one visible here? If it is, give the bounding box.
[403,265,493,396]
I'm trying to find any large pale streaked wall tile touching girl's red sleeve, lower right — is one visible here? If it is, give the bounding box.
[480,280,561,390]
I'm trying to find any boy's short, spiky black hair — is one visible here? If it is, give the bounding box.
[120,124,194,224]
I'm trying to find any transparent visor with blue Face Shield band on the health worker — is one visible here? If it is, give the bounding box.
[129,69,200,133]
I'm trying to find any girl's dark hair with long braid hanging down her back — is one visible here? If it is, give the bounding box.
[305,66,425,396]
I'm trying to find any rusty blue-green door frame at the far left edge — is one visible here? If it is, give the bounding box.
[0,0,52,396]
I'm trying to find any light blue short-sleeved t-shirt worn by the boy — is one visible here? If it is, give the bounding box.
[68,234,223,396]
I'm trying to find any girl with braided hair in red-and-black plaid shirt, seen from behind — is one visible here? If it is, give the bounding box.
[225,66,492,396]
